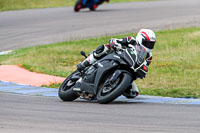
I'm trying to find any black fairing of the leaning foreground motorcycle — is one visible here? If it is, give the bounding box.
[78,48,145,95]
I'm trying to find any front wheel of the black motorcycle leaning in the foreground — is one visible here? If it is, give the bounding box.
[97,73,132,104]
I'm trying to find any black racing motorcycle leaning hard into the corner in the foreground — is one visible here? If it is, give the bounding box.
[58,44,148,104]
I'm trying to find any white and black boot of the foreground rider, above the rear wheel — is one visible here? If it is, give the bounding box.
[77,54,96,72]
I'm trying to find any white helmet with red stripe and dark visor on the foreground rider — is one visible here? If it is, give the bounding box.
[136,29,156,52]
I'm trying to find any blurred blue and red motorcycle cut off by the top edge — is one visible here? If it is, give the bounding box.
[74,0,109,12]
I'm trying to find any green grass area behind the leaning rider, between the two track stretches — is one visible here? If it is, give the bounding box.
[0,27,200,97]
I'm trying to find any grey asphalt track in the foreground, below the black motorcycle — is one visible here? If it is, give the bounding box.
[0,93,200,133]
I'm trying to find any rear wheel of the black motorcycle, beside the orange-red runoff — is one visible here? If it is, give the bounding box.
[58,71,79,101]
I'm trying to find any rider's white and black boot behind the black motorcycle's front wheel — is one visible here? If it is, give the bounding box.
[123,82,139,98]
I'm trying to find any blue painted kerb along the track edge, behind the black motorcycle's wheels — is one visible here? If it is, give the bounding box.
[0,81,200,105]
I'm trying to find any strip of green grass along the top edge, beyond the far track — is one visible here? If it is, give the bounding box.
[0,0,152,11]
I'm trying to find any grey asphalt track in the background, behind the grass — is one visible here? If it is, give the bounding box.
[0,0,200,51]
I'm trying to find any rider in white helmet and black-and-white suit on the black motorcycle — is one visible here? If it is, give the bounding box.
[77,29,156,98]
